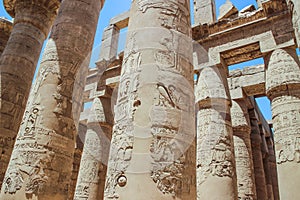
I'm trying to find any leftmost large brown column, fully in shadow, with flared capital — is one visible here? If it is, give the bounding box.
[0,0,60,191]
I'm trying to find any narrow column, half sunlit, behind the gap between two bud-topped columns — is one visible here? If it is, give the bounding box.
[231,100,257,200]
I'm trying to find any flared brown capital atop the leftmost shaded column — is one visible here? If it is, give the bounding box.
[3,0,61,17]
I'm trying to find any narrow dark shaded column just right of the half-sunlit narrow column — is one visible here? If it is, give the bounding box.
[249,109,268,200]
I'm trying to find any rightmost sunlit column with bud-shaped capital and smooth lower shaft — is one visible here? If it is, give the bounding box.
[265,48,300,199]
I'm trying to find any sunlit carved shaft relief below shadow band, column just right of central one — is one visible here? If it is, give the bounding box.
[197,109,235,184]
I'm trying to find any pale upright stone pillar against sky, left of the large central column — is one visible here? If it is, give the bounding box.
[99,25,120,61]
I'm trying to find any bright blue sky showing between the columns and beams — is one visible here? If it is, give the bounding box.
[0,0,299,119]
